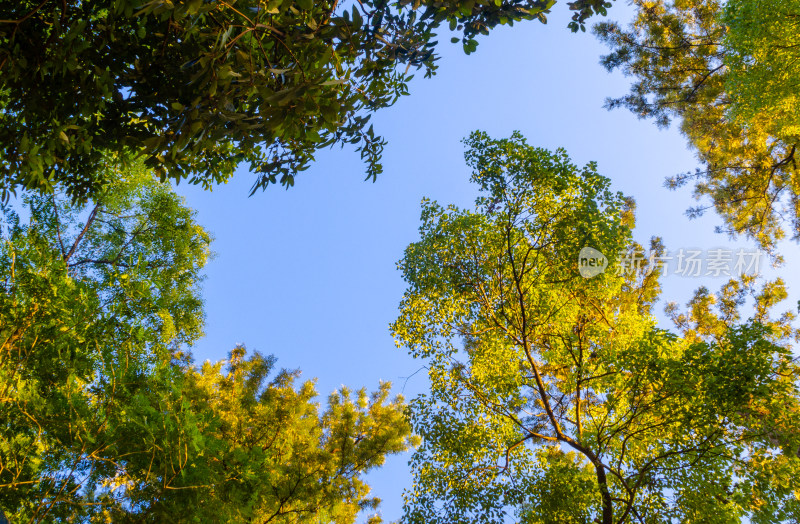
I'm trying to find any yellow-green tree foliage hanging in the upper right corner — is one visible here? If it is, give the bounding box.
[596,0,800,254]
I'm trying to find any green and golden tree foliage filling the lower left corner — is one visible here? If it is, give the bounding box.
[0,167,414,523]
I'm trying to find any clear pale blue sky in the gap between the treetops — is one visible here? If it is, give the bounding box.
[179,3,800,521]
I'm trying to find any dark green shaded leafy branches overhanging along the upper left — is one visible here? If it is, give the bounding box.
[0,0,609,199]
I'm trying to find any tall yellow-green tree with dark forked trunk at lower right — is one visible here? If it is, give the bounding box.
[392,133,800,524]
